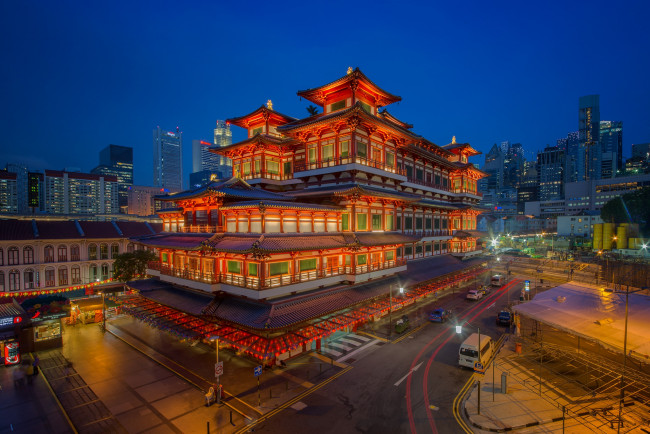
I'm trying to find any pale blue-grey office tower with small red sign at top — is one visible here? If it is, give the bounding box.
[153,127,183,190]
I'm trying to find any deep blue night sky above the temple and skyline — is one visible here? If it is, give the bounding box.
[0,0,650,185]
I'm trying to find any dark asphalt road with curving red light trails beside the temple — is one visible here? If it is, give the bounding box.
[254,275,522,434]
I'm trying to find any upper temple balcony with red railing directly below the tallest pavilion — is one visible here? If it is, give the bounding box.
[294,156,406,181]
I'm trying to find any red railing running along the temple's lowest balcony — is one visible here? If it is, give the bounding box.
[148,259,406,289]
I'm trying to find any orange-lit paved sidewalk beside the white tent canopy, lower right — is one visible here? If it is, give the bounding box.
[463,336,648,434]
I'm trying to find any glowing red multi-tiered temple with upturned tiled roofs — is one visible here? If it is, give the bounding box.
[132,69,486,362]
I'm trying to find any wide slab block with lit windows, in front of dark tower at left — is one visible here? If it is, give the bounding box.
[43,170,119,214]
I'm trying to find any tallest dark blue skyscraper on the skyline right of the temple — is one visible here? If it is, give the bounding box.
[576,95,601,181]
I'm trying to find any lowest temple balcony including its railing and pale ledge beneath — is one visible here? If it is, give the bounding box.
[147,259,406,299]
